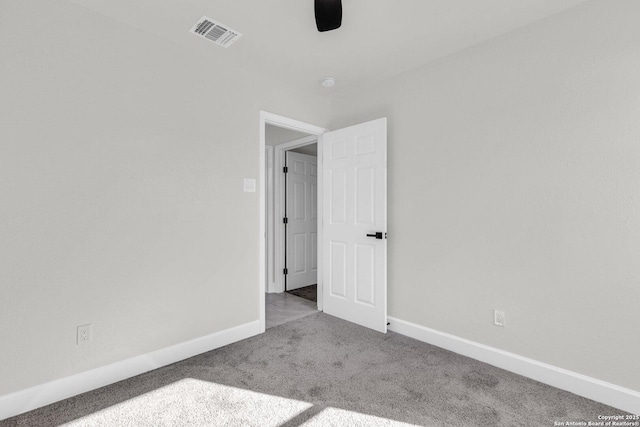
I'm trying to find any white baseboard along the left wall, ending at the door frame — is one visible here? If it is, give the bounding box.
[0,320,261,420]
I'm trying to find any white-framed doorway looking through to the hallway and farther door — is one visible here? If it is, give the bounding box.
[260,112,325,331]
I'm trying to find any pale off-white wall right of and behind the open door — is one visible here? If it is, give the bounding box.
[329,0,640,391]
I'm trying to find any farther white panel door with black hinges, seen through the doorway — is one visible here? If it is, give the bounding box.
[286,151,318,290]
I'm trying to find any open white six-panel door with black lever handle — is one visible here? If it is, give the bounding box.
[321,118,387,332]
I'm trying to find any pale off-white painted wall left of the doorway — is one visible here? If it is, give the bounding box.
[0,0,328,395]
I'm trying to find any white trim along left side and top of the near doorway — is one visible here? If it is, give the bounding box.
[258,111,327,333]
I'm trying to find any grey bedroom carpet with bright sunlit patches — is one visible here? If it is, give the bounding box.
[0,312,622,427]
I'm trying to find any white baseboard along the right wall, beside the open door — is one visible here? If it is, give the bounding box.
[388,317,640,415]
